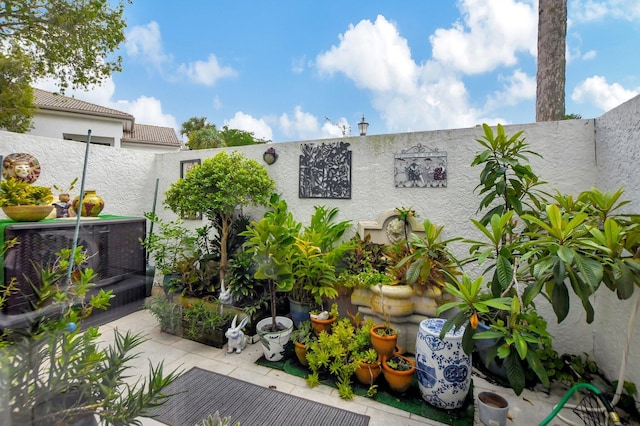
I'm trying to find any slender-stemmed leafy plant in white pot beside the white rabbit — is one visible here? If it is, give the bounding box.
[241,194,301,361]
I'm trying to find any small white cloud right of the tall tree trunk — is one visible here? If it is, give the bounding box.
[571,75,638,111]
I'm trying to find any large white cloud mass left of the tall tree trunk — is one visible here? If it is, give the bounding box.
[316,4,537,131]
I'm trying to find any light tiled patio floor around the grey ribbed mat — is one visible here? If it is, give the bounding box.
[100,311,636,426]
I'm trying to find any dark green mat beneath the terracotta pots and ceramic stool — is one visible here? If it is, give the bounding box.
[256,345,474,426]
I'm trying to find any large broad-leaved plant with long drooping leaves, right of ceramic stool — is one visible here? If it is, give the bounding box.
[439,125,640,394]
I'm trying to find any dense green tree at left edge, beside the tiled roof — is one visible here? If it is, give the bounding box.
[0,53,35,133]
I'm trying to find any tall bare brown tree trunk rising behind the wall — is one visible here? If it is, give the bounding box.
[536,0,567,121]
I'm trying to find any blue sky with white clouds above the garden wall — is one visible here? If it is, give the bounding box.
[37,0,640,142]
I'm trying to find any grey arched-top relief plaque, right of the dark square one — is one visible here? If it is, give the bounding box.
[394,144,447,188]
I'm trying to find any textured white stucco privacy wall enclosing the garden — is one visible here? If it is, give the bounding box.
[0,97,640,392]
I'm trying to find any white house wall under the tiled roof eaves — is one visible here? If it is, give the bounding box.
[29,110,122,147]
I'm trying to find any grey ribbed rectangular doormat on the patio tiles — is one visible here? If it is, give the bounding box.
[151,367,369,426]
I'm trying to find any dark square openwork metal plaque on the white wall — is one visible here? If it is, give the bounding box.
[299,142,351,199]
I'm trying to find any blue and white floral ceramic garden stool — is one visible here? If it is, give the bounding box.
[416,318,471,410]
